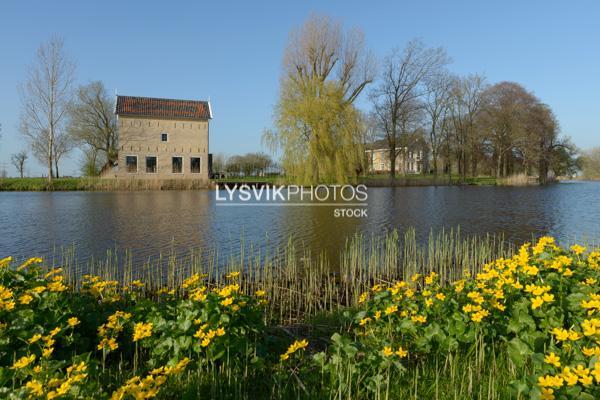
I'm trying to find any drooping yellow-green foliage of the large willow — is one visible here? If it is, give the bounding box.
[273,79,364,184]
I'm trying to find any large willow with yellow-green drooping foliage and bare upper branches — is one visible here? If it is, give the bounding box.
[264,15,373,184]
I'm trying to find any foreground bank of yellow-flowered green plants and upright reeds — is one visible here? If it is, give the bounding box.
[0,233,600,399]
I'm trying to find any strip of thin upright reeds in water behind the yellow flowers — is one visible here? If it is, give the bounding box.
[55,229,514,324]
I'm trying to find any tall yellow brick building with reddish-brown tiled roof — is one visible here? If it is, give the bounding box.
[114,96,212,181]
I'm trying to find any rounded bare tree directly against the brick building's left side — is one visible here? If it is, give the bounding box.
[67,81,118,170]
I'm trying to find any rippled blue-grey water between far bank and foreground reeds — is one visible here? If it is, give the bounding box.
[0,182,600,266]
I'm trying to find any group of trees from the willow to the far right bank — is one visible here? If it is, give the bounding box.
[263,15,577,183]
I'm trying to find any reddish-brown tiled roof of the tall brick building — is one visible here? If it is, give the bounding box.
[115,96,212,120]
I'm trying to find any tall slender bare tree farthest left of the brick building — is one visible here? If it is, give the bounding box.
[20,37,75,182]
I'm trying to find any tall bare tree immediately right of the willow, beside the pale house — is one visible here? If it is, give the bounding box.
[371,40,450,177]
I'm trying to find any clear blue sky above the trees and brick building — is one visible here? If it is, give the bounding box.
[0,0,600,175]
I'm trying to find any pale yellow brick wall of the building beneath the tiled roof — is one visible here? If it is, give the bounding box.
[116,115,209,180]
